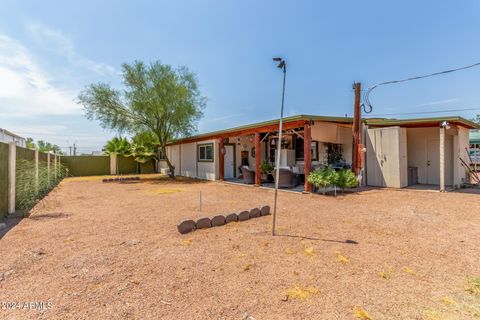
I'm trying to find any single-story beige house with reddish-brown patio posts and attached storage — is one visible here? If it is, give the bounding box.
[159,115,478,191]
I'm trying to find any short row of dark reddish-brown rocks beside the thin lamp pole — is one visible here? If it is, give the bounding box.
[177,206,270,234]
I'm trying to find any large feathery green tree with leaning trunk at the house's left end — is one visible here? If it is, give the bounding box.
[78,61,206,177]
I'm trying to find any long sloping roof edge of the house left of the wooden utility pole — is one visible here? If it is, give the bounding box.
[171,114,353,144]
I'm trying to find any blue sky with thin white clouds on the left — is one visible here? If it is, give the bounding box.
[0,0,480,152]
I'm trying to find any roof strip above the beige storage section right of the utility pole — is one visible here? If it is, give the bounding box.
[365,116,480,129]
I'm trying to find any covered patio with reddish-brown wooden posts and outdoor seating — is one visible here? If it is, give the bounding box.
[216,116,352,192]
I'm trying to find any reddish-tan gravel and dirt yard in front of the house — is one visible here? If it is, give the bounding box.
[0,178,480,320]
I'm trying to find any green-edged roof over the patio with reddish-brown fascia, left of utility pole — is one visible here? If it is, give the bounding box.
[169,114,353,145]
